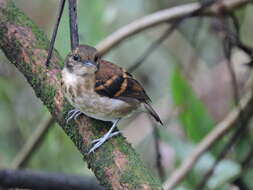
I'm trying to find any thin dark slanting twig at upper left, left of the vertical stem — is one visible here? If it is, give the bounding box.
[46,0,65,67]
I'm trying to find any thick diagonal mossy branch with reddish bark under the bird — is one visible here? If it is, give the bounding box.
[0,0,162,190]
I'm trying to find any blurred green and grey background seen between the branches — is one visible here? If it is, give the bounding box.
[0,0,253,190]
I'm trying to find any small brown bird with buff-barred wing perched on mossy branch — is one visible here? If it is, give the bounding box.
[61,45,162,153]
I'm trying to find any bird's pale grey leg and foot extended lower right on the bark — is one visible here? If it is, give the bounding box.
[88,119,120,154]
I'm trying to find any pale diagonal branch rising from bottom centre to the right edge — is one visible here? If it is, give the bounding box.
[164,92,253,190]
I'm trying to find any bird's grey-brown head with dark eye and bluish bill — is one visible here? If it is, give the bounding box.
[64,45,100,76]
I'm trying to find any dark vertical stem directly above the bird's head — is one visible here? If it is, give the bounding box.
[68,0,79,50]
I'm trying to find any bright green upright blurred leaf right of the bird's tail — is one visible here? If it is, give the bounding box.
[171,67,214,143]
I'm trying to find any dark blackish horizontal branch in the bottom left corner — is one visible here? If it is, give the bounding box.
[0,170,103,190]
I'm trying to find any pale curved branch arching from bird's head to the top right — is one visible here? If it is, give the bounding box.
[96,0,251,55]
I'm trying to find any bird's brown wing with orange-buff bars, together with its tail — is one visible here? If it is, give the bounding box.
[95,60,162,124]
